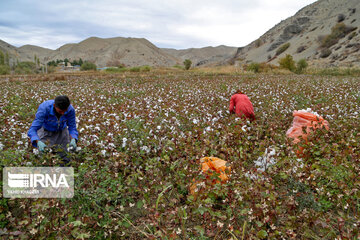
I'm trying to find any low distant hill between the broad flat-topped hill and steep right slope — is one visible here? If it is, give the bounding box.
[162,45,238,67]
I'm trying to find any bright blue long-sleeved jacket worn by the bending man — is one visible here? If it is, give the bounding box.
[28,100,79,147]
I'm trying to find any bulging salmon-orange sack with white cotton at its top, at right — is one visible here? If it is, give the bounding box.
[286,109,329,157]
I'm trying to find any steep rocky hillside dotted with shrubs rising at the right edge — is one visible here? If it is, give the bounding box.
[232,0,360,67]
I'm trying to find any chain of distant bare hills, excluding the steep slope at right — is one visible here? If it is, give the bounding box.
[0,37,237,67]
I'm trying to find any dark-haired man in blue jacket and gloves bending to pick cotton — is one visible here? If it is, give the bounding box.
[28,96,78,166]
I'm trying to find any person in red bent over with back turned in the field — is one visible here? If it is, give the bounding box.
[229,90,255,121]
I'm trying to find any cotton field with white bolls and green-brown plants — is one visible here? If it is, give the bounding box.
[0,72,360,239]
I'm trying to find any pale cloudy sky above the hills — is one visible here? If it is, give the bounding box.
[0,0,316,50]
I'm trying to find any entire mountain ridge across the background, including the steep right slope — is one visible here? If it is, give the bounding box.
[0,0,360,67]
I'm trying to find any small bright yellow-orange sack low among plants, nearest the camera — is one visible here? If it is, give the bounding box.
[190,157,231,197]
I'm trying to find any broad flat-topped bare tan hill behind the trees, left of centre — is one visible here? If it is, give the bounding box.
[44,37,183,67]
